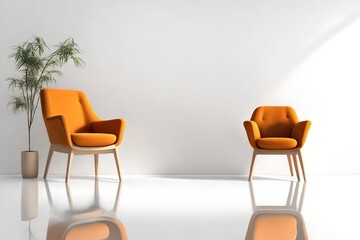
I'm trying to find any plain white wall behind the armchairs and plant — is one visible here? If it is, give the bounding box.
[0,0,360,174]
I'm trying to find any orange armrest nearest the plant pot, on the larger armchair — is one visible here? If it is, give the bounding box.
[45,115,72,147]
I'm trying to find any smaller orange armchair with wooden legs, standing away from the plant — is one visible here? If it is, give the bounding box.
[244,106,311,181]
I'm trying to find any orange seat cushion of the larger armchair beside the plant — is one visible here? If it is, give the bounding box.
[71,133,116,147]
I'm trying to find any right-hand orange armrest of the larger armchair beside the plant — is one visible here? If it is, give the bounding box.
[92,118,126,146]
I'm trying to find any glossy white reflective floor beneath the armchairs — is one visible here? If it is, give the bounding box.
[0,176,360,240]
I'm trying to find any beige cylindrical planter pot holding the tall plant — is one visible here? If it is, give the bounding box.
[21,151,39,178]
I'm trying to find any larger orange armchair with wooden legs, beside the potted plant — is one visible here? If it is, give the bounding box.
[40,88,126,182]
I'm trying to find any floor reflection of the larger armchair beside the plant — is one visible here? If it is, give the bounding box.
[44,180,127,240]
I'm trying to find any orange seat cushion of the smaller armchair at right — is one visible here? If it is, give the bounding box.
[256,137,297,149]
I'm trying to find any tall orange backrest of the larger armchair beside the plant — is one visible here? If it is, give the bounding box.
[40,88,99,143]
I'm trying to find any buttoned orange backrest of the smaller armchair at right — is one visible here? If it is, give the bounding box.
[251,106,299,137]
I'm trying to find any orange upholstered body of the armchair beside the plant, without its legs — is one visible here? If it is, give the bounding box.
[40,88,125,147]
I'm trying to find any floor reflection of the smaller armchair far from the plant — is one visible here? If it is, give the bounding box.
[246,182,308,240]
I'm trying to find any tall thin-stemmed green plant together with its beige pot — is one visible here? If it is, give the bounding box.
[7,36,84,178]
